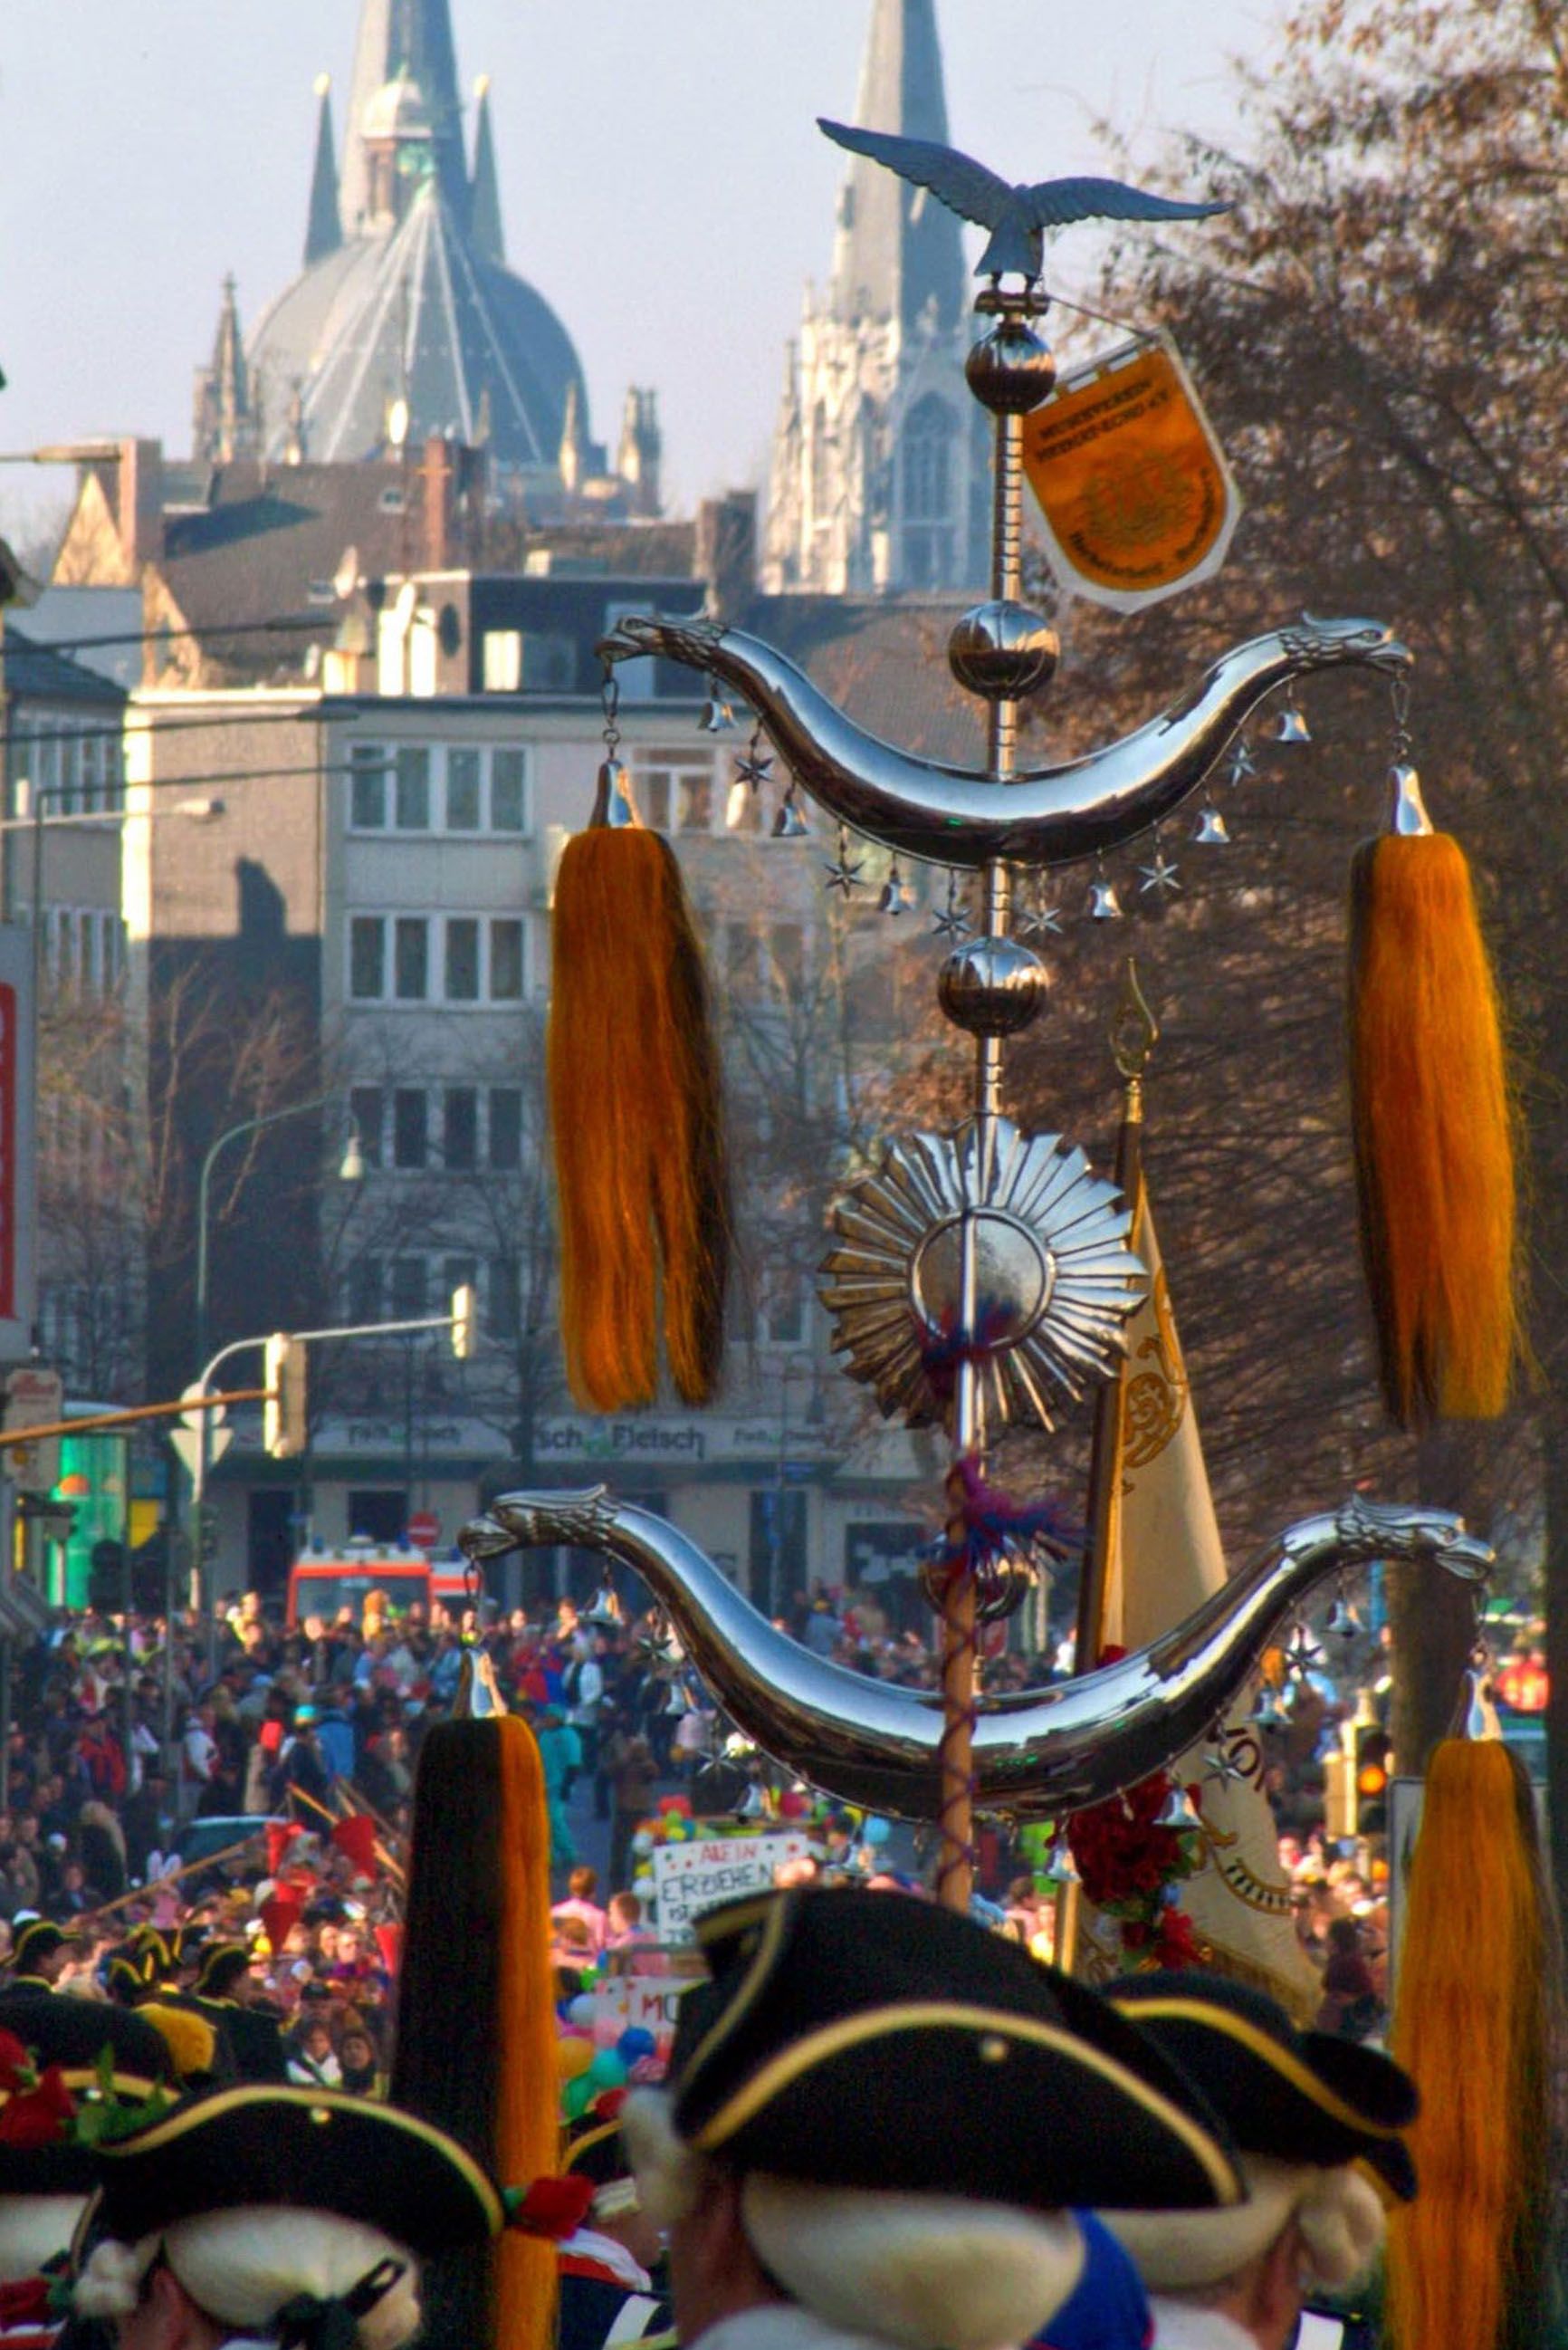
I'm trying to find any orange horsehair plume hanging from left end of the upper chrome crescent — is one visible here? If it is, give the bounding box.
[545,757,729,1413]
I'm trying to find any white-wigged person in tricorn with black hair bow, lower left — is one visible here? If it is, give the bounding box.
[72,2085,570,2350]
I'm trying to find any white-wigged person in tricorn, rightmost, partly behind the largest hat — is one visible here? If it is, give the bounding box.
[1100,1971,1418,2350]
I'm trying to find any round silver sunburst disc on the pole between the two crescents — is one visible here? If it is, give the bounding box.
[820,1118,1145,1429]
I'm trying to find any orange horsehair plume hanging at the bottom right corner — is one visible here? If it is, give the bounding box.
[1387,1739,1556,2350]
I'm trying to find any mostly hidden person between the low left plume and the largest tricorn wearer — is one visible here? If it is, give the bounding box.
[555,2089,670,2350]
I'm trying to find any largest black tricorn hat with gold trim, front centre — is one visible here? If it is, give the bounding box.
[670,1887,1244,2209]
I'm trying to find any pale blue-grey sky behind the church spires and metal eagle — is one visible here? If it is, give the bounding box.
[0,0,1281,529]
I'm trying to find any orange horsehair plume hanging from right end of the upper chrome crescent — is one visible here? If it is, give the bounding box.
[1350,763,1518,1426]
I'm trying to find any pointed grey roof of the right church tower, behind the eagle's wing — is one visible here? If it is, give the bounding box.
[832,0,964,329]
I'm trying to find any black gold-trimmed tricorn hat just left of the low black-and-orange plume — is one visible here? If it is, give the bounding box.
[90,2082,505,2259]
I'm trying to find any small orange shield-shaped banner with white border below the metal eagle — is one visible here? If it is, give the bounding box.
[1023,333,1241,611]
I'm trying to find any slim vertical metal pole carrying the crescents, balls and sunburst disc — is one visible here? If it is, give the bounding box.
[935,399,1023,1911]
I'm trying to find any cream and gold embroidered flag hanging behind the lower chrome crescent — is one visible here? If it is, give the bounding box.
[1081,1177,1319,2023]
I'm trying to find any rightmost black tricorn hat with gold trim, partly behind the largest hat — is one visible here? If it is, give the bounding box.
[1107,1971,1420,2202]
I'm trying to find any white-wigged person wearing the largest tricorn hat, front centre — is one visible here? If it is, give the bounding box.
[623,1889,1241,2350]
